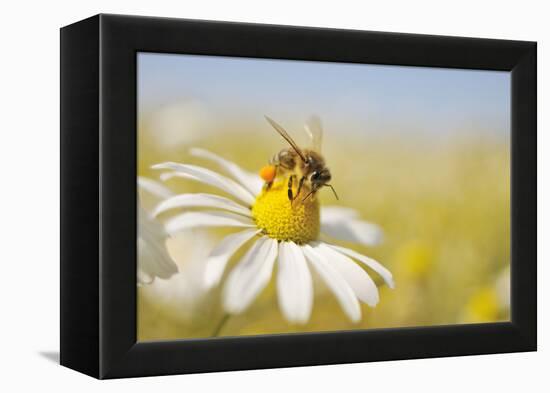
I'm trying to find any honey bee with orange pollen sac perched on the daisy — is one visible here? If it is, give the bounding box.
[260,116,338,203]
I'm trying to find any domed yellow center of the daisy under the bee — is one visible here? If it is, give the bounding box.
[252,178,320,244]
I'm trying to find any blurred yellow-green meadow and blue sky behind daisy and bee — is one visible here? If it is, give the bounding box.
[137,53,510,340]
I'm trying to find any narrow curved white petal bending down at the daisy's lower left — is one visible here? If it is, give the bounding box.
[204,229,260,288]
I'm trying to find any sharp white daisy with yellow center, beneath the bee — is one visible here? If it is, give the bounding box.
[153,149,394,324]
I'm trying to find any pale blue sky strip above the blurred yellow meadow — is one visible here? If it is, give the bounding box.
[138,53,510,136]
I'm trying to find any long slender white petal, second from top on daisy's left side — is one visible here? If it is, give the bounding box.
[152,162,254,206]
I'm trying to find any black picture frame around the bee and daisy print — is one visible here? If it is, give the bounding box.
[61,15,537,378]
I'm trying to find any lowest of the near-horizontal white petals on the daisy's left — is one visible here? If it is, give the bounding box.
[165,211,255,234]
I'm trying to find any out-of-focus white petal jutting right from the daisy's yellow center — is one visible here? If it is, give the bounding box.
[321,207,382,246]
